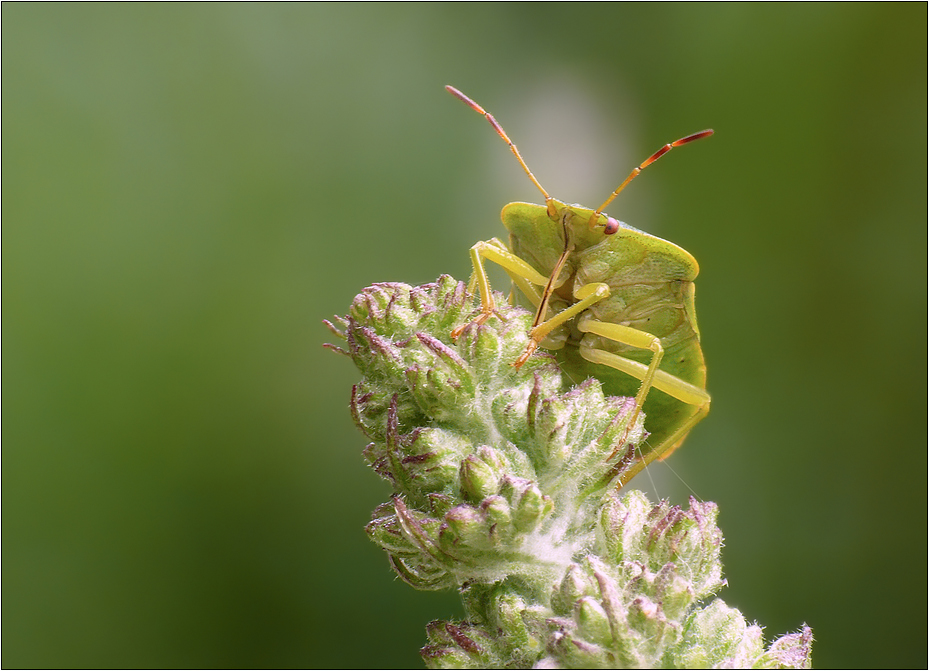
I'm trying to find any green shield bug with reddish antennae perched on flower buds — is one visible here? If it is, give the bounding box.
[445,86,713,486]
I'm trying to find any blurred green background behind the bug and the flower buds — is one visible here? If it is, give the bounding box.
[2,3,927,668]
